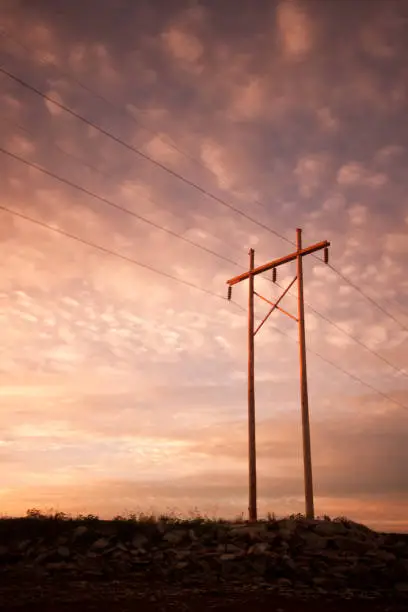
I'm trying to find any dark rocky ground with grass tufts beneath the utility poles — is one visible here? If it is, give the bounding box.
[0,518,408,612]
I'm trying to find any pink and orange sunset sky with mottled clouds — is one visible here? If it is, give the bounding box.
[0,0,408,531]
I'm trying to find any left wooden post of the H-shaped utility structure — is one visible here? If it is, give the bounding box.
[248,249,258,522]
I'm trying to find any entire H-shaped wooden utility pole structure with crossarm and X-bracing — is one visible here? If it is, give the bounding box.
[227,229,330,522]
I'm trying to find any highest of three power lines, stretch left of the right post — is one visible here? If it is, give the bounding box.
[0,67,291,242]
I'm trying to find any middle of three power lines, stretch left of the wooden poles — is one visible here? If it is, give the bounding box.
[0,147,238,266]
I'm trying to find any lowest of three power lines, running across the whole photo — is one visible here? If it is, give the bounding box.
[0,198,408,410]
